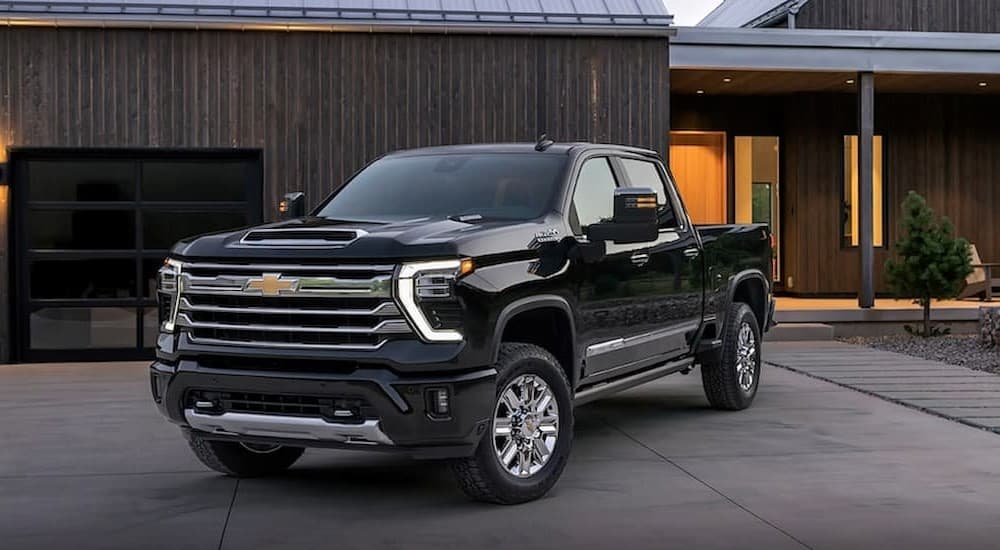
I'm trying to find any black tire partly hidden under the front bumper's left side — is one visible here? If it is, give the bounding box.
[188,433,305,477]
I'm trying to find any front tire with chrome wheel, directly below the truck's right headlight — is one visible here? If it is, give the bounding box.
[452,343,573,504]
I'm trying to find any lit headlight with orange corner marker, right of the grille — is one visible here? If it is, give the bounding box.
[396,259,474,342]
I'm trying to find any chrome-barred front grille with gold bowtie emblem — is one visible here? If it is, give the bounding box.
[176,263,413,350]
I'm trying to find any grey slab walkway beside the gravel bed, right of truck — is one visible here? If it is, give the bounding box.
[767,342,1000,432]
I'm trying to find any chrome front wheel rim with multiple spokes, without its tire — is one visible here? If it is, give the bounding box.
[493,374,559,478]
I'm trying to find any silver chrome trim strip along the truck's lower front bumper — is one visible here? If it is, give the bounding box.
[184,409,394,445]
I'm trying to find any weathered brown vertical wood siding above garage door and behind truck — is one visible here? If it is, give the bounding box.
[0,28,669,214]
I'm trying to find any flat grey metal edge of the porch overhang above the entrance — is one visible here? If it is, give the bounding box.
[670,27,1000,74]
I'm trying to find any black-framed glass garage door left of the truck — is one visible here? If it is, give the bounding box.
[10,149,262,361]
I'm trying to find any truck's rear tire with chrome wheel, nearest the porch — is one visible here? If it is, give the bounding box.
[701,302,761,411]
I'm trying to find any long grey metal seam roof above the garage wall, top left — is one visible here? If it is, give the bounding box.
[0,0,673,35]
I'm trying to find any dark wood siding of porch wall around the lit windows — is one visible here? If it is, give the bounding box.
[672,94,1000,295]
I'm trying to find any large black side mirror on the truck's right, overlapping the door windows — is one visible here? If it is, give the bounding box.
[586,187,659,244]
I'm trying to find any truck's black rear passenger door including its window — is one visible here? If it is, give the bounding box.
[616,155,704,359]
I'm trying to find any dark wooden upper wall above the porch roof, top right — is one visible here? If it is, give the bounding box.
[795,0,1000,32]
